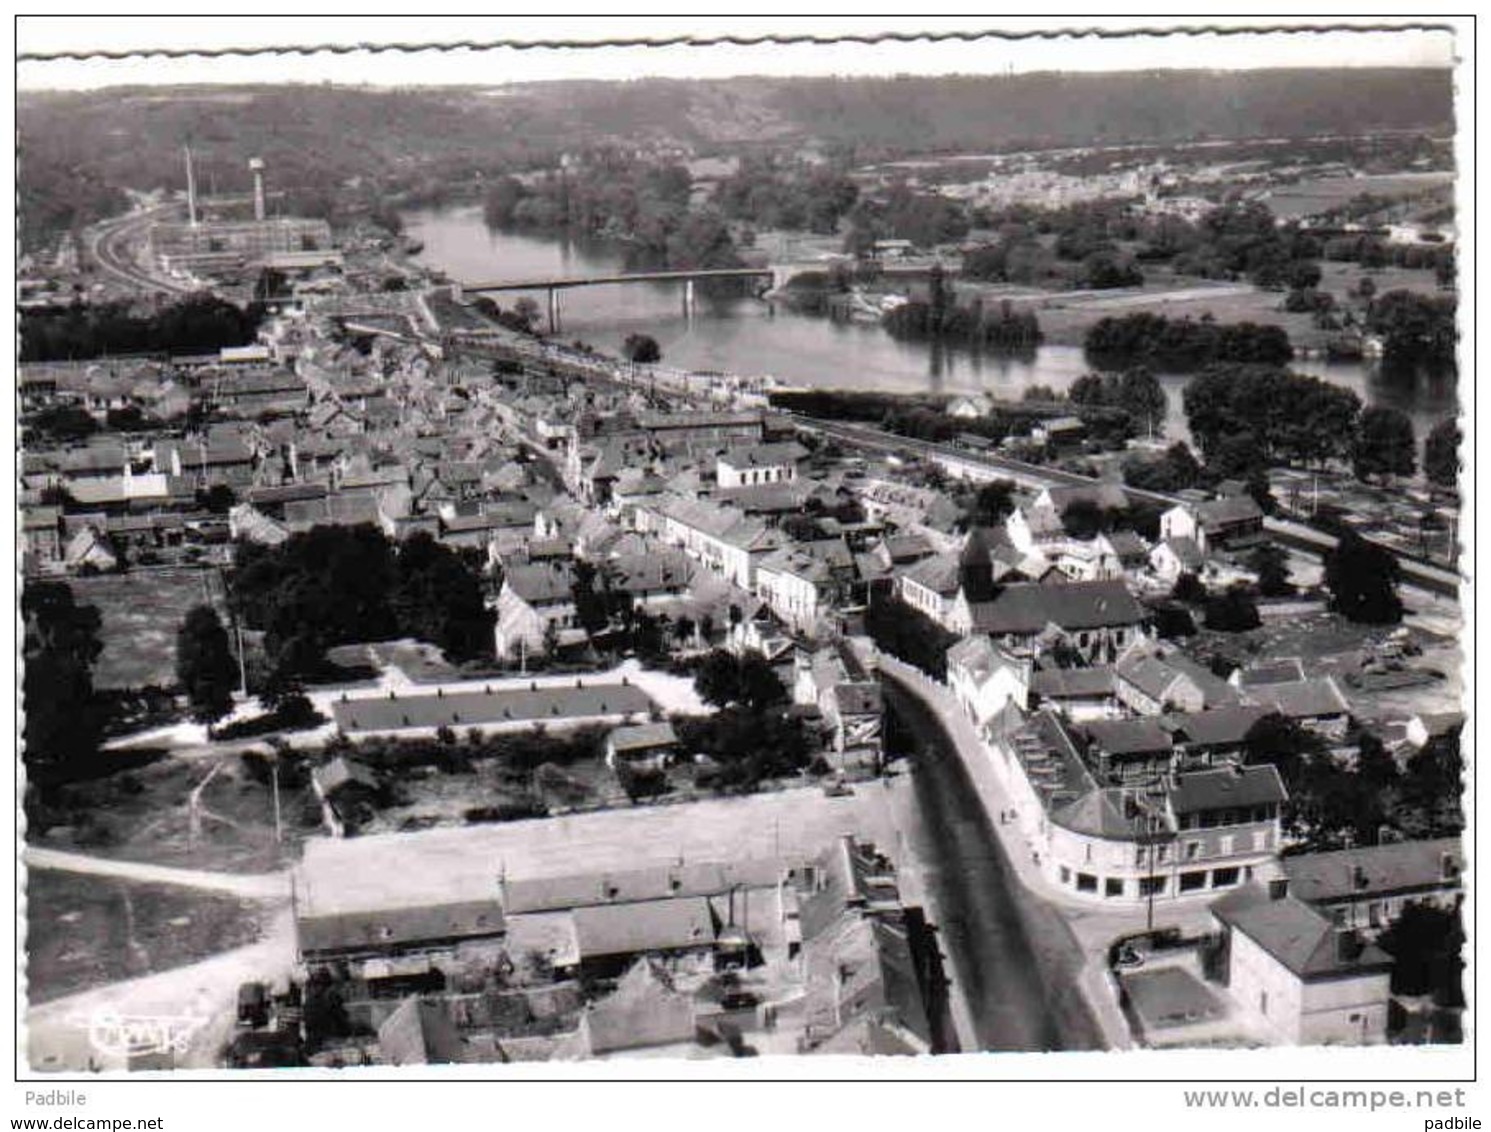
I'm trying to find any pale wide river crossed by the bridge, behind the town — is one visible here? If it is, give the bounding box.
[404,207,1457,438]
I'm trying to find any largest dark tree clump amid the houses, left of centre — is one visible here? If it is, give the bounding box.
[231,525,491,680]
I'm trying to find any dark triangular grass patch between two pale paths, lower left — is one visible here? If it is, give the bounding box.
[25,870,264,1004]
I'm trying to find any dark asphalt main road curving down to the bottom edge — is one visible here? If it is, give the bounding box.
[884,680,1103,1051]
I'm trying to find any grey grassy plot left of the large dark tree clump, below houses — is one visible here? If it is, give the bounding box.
[69,570,225,688]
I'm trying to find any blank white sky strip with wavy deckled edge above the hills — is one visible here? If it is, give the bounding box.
[16,12,1457,89]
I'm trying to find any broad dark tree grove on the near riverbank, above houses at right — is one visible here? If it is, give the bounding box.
[1182,365,1361,474]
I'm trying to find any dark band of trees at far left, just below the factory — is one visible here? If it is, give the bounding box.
[21,294,261,361]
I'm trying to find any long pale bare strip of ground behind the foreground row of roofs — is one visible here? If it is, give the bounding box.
[295,782,904,914]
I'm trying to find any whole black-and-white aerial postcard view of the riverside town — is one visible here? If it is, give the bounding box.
[15,13,1472,1085]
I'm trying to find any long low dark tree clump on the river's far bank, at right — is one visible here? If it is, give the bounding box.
[1082,312,1294,371]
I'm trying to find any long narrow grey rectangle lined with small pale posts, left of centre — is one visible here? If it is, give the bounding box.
[331,683,655,738]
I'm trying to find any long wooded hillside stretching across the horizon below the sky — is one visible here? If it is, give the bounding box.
[16,67,1454,249]
